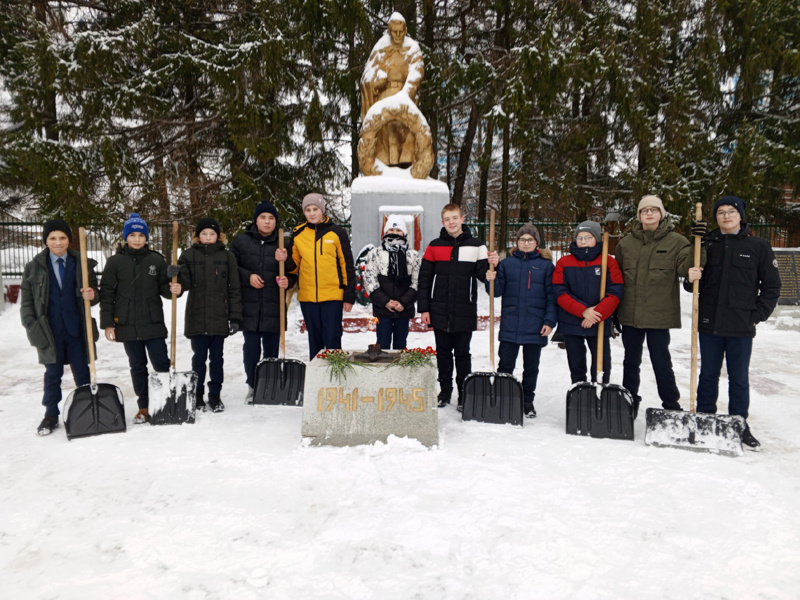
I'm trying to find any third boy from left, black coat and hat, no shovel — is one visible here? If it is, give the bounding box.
[178,219,242,412]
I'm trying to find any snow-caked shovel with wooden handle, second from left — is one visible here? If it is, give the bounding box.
[148,221,197,425]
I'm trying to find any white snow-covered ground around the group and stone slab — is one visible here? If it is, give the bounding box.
[0,294,800,600]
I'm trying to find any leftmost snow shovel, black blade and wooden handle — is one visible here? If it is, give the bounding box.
[64,227,126,440]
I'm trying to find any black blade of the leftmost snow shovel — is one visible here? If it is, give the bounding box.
[64,383,126,440]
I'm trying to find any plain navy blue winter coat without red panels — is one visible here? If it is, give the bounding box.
[486,248,557,346]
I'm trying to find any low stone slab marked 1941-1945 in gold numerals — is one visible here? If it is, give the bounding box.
[302,352,439,447]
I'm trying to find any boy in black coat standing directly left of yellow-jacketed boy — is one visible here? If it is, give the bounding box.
[231,200,297,401]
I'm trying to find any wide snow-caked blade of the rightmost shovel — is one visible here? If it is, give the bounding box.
[644,408,745,456]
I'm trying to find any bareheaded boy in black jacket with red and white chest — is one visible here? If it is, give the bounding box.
[417,204,489,411]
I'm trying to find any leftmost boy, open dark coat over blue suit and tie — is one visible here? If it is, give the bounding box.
[20,219,100,435]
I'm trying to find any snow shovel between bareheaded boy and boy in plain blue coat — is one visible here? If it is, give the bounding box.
[461,210,523,426]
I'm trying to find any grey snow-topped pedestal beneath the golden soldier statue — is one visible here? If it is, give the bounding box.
[350,175,450,257]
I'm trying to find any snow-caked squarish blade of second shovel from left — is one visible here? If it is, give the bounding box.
[147,371,197,425]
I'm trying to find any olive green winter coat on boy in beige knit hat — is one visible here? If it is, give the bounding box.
[614,219,702,329]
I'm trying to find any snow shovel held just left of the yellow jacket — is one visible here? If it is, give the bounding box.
[253,229,306,406]
